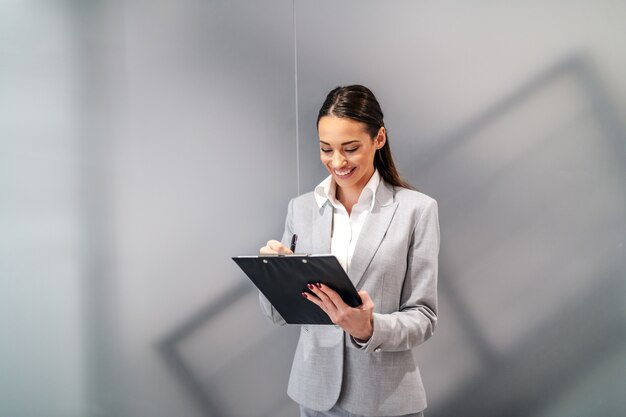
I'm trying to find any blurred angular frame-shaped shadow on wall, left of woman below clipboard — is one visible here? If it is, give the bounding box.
[158,275,298,417]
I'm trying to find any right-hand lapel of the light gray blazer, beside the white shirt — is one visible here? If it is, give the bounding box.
[348,181,398,289]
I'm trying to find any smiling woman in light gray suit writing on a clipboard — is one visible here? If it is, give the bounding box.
[260,85,439,416]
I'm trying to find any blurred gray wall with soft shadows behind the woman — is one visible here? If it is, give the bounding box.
[0,0,626,417]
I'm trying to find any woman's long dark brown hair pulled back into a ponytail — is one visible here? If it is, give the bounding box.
[317,85,415,190]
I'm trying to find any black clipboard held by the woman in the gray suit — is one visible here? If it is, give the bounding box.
[233,254,362,324]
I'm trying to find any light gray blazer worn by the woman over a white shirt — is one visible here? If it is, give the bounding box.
[260,179,439,416]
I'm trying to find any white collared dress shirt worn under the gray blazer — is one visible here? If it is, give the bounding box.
[315,170,380,272]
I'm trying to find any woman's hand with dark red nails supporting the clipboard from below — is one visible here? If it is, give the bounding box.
[302,283,374,342]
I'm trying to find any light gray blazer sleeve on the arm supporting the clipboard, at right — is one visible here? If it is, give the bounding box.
[350,199,440,352]
